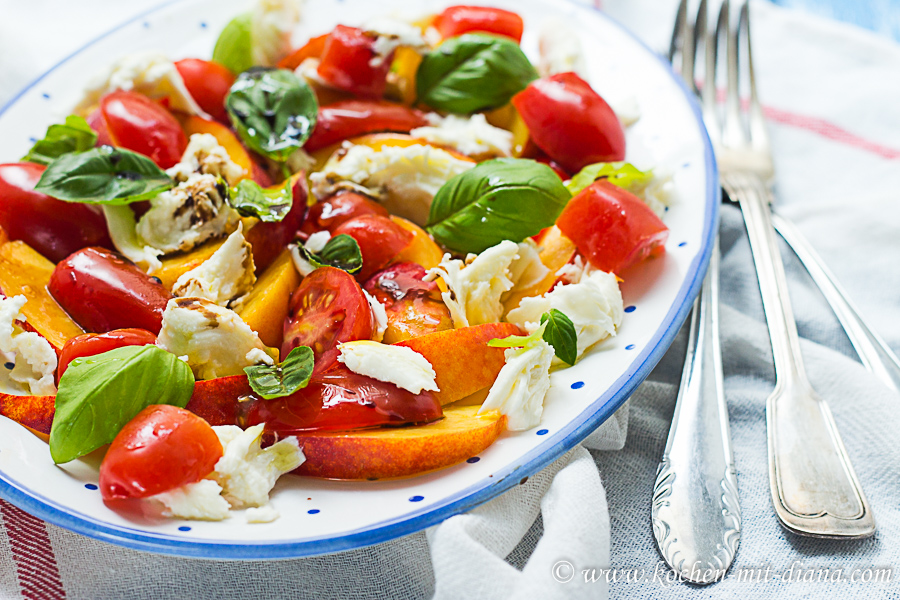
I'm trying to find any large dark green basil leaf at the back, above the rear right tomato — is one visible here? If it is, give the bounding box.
[416,33,538,114]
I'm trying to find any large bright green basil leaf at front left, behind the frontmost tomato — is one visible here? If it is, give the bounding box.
[50,346,194,464]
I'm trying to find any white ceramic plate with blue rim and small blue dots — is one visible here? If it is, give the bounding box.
[0,0,719,559]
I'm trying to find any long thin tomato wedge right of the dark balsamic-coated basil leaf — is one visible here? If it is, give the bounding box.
[303,100,428,152]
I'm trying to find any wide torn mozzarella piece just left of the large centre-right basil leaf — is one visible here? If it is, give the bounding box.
[309,142,475,225]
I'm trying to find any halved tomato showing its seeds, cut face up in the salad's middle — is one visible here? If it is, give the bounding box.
[281,267,374,373]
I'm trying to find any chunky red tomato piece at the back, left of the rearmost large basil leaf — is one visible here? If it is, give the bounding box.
[318,25,391,98]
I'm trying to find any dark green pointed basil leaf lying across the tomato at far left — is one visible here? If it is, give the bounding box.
[34,146,175,205]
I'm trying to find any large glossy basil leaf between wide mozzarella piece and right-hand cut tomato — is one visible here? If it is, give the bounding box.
[426,158,571,254]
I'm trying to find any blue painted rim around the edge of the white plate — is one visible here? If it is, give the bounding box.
[0,0,721,560]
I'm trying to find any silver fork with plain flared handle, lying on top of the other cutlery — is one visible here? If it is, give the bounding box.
[702,0,875,538]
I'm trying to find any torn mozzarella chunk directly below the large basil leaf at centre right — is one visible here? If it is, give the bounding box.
[428,240,519,328]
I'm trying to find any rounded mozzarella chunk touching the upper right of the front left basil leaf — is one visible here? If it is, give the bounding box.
[157,298,275,379]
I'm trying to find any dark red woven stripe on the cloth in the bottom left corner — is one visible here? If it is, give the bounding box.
[0,500,66,600]
